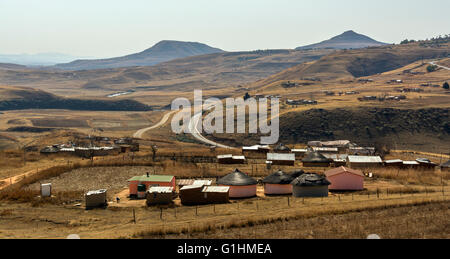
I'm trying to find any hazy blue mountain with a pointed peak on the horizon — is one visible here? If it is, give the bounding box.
[296,31,388,50]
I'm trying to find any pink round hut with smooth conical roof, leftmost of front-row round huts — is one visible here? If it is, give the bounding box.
[217,169,258,198]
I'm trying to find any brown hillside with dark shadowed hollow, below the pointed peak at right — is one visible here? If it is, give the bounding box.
[253,43,450,87]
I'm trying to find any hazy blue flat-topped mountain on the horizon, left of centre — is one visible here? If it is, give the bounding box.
[55,40,224,70]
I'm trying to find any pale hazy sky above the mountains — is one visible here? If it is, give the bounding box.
[0,0,450,57]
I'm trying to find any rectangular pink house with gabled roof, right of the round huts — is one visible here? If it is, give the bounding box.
[325,166,364,191]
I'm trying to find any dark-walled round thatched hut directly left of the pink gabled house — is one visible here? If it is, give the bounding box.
[291,173,331,197]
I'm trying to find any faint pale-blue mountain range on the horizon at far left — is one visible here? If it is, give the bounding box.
[0,53,86,66]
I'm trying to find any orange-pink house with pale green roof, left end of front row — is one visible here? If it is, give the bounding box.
[128,176,175,197]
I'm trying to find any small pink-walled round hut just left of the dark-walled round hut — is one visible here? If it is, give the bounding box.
[262,170,295,195]
